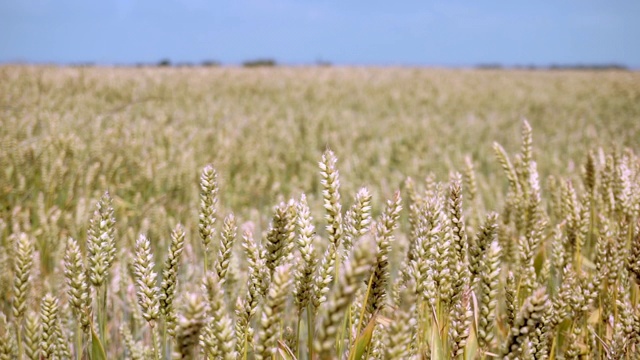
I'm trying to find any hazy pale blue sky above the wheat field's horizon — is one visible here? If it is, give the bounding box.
[0,0,640,68]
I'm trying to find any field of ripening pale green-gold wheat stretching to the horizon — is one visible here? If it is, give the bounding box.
[0,66,640,360]
